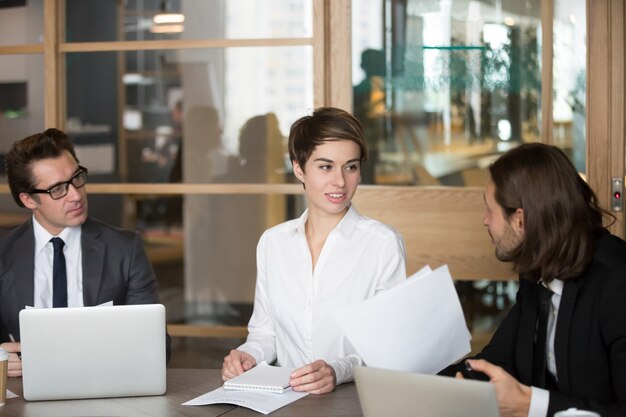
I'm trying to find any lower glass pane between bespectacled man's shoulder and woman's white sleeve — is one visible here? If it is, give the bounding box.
[94,192,304,332]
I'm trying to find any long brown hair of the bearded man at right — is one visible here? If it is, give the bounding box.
[489,143,613,282]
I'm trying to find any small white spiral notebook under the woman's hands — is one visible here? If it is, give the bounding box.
[224,361,294,394]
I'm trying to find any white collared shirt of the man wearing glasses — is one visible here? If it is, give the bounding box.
[33,216,83,308]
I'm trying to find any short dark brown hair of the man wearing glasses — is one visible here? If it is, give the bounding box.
[5,128,78,207]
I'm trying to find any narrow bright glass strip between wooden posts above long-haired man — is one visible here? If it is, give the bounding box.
[552,0,587,172]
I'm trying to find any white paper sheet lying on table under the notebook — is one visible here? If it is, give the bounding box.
[182,387,309,414]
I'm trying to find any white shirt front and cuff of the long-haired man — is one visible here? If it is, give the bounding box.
[528,279,563,417]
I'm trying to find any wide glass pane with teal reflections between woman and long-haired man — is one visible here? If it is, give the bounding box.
[352,0,541,186]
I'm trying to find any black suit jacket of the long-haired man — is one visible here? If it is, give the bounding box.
[441,233,626,416]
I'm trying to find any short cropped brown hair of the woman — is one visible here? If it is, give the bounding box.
[289,107,367,171]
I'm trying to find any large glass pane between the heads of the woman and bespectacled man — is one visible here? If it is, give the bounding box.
[66,46,313,188]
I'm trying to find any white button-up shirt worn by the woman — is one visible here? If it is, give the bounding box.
[238,206,406,384]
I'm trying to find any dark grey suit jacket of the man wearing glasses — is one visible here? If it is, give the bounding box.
[0,219,159,342]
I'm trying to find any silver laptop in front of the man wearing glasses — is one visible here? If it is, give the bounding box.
[20,304,166,400]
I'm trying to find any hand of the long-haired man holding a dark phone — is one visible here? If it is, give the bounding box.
[466,359,532,417]
